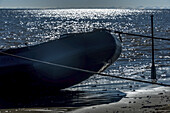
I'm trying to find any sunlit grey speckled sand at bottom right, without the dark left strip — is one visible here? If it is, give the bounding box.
[69,87,170,113]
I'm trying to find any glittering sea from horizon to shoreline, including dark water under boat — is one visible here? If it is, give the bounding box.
[0,9,170,108]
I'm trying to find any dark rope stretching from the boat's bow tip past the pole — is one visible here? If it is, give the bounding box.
[115,31,170,41]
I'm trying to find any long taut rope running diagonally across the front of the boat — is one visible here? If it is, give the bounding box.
[0,51,170,87]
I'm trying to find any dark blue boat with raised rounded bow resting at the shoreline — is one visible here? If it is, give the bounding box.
[0,29,121,91]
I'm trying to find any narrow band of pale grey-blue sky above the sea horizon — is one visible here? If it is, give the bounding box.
[0,0,170,9]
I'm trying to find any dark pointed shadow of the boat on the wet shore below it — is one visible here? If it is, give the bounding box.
[0,90,126,109]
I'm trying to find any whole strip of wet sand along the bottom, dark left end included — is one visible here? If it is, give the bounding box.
[0,86,170,113]
